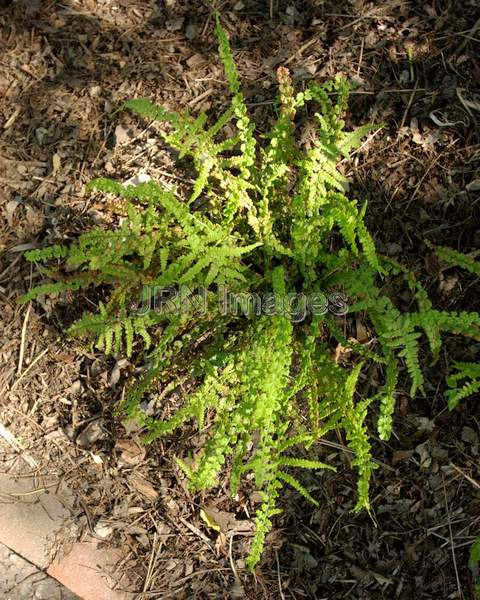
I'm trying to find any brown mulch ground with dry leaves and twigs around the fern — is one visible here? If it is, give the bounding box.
[0,0,480,600]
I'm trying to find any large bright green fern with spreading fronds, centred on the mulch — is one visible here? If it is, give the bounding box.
[22,14,480,568]
